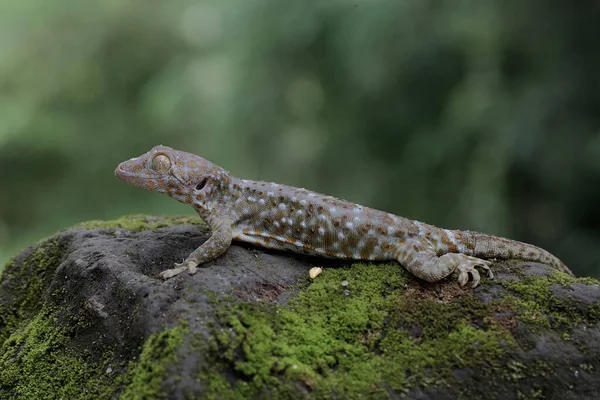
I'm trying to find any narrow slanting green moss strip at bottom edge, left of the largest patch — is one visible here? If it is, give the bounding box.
[120,322,189,400]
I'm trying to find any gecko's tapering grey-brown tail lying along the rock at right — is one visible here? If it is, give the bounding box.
[463,232,574,275]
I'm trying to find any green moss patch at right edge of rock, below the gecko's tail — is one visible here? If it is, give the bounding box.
[502,271,599,330]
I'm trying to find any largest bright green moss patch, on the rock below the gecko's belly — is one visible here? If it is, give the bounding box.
[200,264,514,398]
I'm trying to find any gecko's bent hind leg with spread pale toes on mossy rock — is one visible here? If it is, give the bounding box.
[397,239,494,287]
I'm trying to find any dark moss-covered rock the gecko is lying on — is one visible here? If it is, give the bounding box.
[0,216,600,399]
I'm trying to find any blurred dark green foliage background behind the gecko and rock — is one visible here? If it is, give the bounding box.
[0,0,600,277]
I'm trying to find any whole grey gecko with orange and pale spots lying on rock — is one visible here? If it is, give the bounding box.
[115,146,571,287]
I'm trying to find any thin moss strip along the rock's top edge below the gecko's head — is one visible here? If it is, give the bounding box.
[73,215,206,232]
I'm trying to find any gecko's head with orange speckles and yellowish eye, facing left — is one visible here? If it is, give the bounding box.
[115,145,228,204]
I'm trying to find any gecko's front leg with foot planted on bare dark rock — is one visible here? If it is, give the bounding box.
[159,217,233,279]
